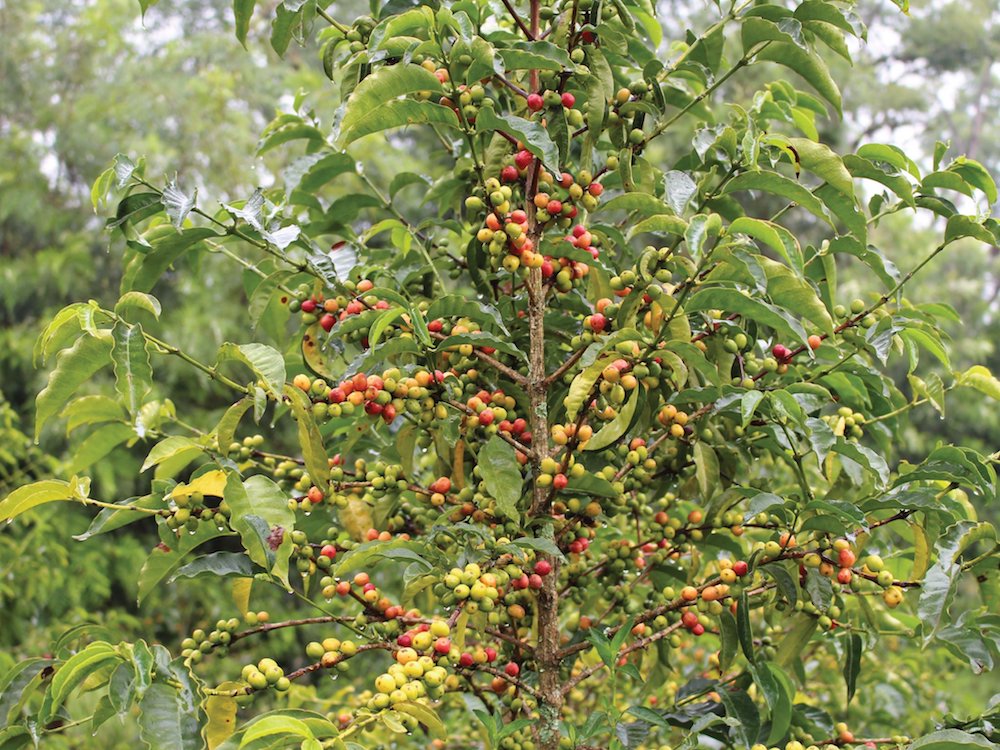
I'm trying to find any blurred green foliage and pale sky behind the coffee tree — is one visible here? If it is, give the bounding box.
[0,0,1000,747]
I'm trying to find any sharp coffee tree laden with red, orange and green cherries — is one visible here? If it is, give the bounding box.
[0,0,1000,750]
